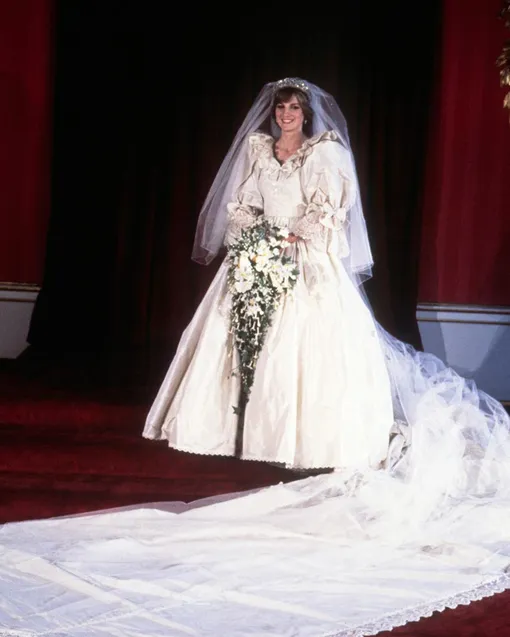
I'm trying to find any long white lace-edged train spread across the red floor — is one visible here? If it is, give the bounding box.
[0,438,510,637]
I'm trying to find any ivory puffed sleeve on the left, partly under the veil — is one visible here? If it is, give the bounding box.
[225,134,265,246]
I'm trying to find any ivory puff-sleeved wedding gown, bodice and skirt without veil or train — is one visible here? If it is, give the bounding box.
[144,132,393,468]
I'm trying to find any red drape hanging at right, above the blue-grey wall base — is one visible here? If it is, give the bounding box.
[420,0,510,305]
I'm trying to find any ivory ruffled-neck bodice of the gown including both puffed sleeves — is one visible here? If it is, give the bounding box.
[226,131,356,256]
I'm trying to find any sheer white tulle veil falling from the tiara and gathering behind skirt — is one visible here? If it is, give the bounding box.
[193,78,510,520]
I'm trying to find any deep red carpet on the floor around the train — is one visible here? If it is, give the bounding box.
[0,365,510,637]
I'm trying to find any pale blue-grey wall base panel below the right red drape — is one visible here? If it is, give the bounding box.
[416,303,510,406]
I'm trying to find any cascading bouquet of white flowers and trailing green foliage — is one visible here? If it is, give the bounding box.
[227,217,299,413]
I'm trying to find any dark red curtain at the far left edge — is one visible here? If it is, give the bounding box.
[0,0,53,283]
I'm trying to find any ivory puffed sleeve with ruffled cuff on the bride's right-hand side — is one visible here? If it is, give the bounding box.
[293,138,357,257]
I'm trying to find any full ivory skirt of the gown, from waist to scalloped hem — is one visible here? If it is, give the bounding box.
[144,219,393,468]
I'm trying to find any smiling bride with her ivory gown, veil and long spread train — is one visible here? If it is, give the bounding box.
[0,78,510,637]
